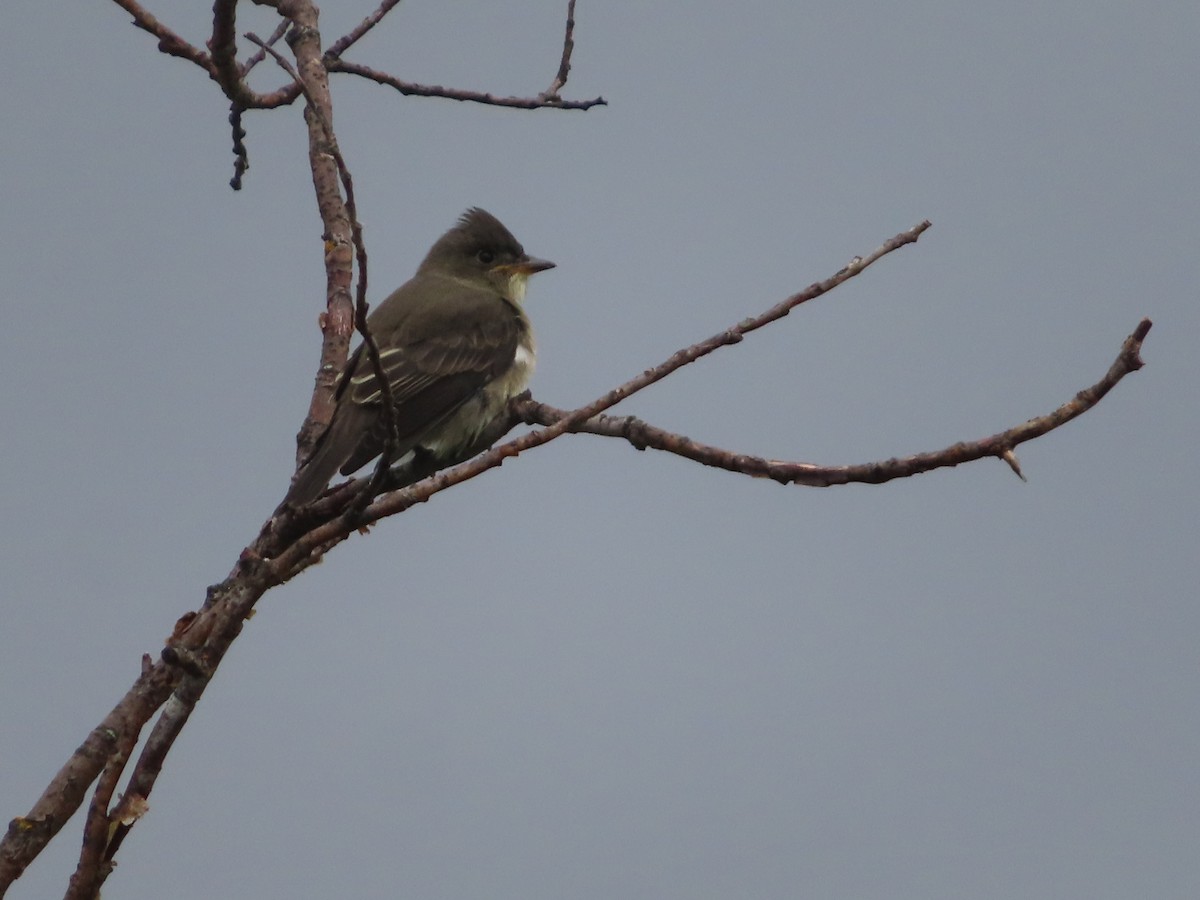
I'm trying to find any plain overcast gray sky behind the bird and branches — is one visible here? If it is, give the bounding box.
[0,0,1200,900]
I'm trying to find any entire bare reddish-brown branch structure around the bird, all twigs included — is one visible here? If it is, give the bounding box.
[11,0,1151,898]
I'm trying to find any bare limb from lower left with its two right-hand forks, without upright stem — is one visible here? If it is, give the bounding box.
[0,200,1150,890]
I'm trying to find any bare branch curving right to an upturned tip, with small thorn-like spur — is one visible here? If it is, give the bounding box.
[514,319,1151,487]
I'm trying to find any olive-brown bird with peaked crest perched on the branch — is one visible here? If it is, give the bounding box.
[284,206,554,506]
